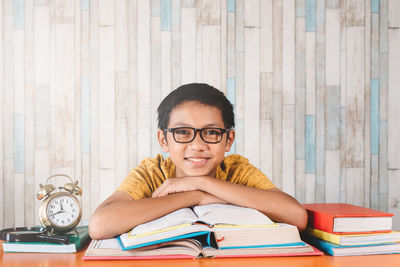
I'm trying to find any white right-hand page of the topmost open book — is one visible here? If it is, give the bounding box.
[193,204,274,227]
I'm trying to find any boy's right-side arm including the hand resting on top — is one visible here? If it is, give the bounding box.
[153,176,307,231]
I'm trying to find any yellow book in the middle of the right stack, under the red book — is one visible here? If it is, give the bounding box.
[305,228,400,246]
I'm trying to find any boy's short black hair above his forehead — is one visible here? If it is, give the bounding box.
[157,83,235,130]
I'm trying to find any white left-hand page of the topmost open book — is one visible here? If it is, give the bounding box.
[130,208,197,237]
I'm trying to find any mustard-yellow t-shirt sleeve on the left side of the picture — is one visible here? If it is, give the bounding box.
[116,165,154,200]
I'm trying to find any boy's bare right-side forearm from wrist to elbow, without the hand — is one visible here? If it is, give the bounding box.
[200,178,307,230]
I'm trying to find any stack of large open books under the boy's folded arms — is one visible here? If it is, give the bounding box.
[83,204,322,260]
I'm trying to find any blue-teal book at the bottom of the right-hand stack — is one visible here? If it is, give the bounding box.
[302,234,400,256]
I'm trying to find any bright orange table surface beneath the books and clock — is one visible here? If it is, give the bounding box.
[0,245,400,267]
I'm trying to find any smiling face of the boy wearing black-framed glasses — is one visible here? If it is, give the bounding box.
[158,101,235,177]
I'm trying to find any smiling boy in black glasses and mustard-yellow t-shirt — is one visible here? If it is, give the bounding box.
[89,84,307,239]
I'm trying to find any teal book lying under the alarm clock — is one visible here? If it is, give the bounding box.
[3,226,90,253]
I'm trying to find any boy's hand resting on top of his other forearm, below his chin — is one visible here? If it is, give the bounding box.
[152,177,200,197]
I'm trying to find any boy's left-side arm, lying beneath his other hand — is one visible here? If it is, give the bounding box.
[89,191,226,239]
